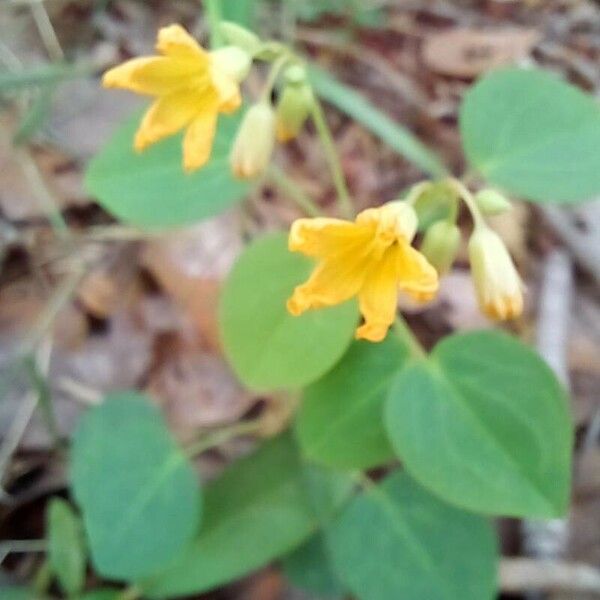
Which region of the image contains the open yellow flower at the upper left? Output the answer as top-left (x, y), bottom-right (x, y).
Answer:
top-left (103, 25), bottom-right (250, 171)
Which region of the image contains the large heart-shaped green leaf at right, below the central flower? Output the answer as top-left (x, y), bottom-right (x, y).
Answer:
top-left (386, 331), bottom-right (572, 517)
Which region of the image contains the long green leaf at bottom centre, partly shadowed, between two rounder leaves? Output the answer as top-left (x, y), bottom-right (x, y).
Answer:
top-left (143, 435), bottom-right (350, 598)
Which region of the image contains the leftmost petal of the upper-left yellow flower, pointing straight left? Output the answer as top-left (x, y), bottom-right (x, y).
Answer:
top-left (102, 56), bottom-right (202, 96)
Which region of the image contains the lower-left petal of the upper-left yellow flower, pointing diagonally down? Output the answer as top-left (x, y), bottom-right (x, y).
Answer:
top-left (134, 91), bottom-right (203, 151)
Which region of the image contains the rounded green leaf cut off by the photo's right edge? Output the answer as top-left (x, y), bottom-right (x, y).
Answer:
top-left (460, 69), bottom-right (600, 202)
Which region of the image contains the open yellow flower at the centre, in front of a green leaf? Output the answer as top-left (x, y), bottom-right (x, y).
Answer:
top-left (287, 202), bottom-right (438, 342)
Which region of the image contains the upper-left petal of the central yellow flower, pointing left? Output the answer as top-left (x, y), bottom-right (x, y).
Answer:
top-left (289, 217), bottom-right (373, 258)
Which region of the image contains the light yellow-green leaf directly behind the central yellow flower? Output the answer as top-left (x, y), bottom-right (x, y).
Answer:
top-left (219, 233), bottom-right (358, 390)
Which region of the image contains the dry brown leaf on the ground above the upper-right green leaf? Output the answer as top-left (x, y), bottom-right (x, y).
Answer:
top-left (422, 28), bottom-right (540, 78)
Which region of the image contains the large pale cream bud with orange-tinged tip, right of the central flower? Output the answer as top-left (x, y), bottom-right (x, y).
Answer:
top-left (469, 226), bottom-right (523, 321)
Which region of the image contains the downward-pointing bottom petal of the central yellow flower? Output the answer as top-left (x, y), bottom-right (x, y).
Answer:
top-left (356, 245), bottom-right (401, 342)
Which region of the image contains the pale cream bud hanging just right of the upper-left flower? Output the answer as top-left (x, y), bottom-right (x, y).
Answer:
top-left (229, 102), bottom-right (275, 179)
